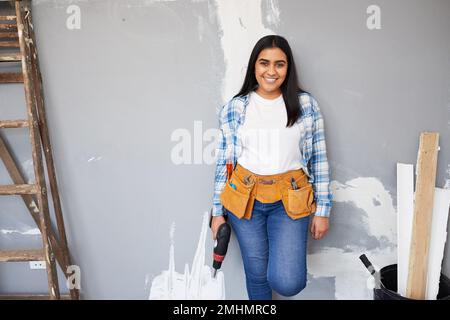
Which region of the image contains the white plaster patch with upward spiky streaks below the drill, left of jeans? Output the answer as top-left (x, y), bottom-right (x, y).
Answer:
top-left (149, 212), bottom-right (225, 300)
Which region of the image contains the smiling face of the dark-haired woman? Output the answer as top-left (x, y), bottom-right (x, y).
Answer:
top-left (255, 48), bottom-right (288, 99)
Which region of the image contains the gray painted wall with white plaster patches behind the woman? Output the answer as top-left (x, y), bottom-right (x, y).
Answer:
top-left (0, 0), bottom-right (450, 299)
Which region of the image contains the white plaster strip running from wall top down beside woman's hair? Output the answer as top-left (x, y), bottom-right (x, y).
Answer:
top-left (216, 0), bottom-right (279, 107)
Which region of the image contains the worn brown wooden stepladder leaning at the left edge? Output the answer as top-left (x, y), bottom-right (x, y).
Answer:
top-left (0, 0), bottom-right (79, 299)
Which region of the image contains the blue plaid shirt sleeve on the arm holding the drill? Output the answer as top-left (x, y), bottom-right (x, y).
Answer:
top-left (212, 105), bottom-right (230, 216)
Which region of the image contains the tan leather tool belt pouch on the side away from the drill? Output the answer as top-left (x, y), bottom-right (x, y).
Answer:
top-left (282, 183), bottom-right (316, 220)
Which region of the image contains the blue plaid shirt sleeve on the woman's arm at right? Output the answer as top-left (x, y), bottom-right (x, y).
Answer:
top-left (309, 99), bottom-right (332, 217)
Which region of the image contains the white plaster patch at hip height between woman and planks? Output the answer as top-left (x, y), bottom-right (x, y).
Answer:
top-left (331, 177), bottom-right (397, 243)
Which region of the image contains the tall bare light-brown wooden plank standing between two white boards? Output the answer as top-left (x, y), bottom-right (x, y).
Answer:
top-left (406, 132), bottom-right (439, 300)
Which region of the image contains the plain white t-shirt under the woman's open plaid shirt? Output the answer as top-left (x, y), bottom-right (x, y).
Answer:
top-left (237, 91), bottom-right (302, 175)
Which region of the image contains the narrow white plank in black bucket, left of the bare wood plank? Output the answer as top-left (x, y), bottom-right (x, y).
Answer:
top-left (397, 163), bottom-right (414, 297)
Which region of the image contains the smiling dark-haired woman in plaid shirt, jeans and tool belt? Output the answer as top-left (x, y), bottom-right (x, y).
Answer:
top-left (211, 35), bottom-right (332, 300)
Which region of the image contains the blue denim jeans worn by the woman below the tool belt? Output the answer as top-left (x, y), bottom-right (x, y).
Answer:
top-left (226, 200), bottom-right (309, 300)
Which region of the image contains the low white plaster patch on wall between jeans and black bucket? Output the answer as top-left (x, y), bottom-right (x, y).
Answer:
top-left (308, 248), bottom-right (397, 300)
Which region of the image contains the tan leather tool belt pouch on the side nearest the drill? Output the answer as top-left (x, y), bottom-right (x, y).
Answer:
top-left (220, 172), bottom-right (254, 219)
